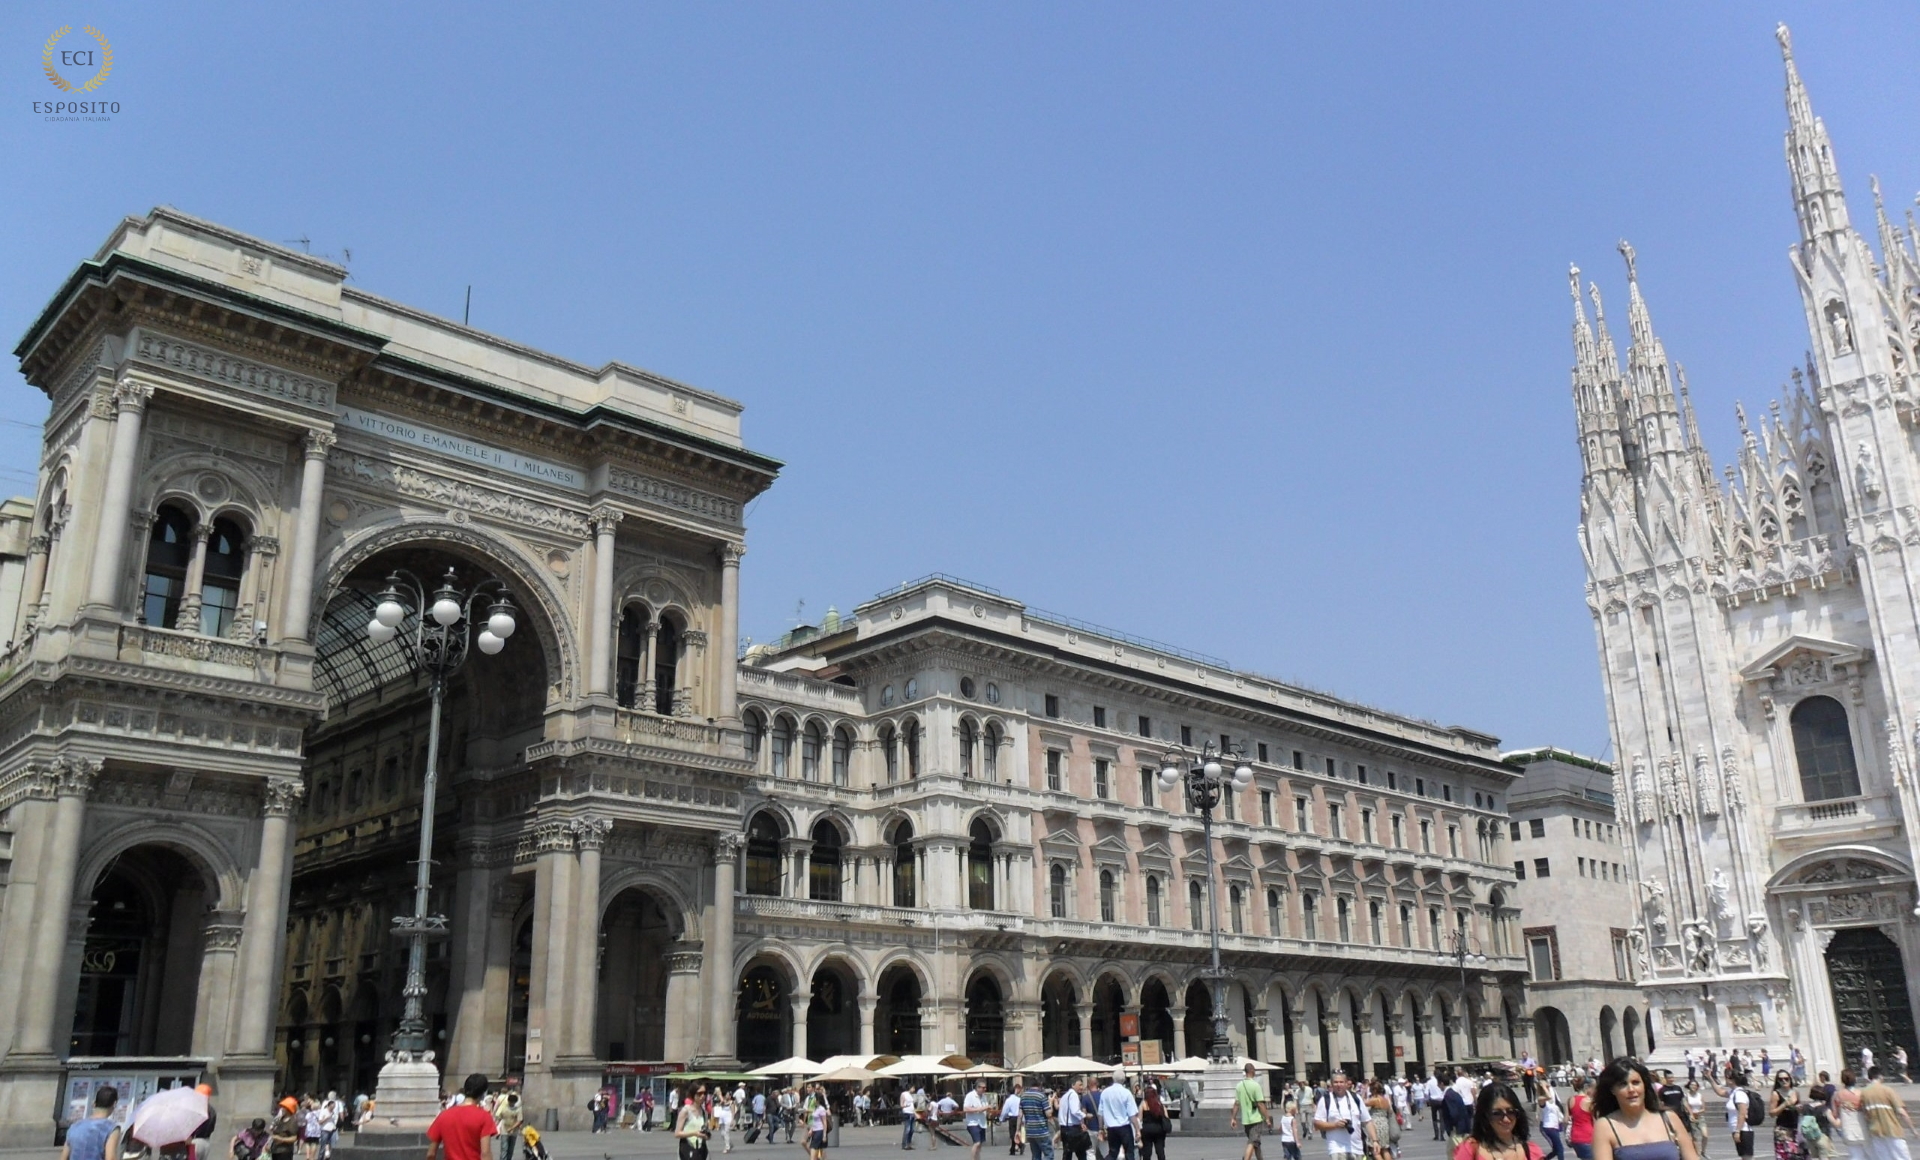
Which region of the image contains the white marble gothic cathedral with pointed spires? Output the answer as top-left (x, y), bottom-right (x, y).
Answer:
top-left (1572, 27), bottom-right (1920, 1072)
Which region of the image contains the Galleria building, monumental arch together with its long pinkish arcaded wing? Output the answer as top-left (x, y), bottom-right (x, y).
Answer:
top-left (0, 209), bottom-right (1528, 1145)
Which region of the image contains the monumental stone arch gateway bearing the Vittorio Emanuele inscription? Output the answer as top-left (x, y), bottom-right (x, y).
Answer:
top-left (0, 209), bottom-right (780, 1145)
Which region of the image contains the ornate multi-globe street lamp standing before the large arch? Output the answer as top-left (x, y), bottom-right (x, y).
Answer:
top-left (367, 567), bottom-right (518, 1067)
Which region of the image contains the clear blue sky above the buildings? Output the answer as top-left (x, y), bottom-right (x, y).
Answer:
top-left (0, 2), bottom-right (1920, 753)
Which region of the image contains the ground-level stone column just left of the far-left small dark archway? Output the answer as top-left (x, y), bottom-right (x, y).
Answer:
top-left (10, 757), bottom-right (100, 1060)
